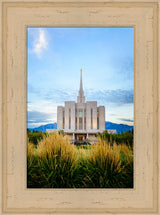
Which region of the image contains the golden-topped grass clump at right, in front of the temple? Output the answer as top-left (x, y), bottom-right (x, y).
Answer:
top-left (82, 140), bottom-right (123, 188)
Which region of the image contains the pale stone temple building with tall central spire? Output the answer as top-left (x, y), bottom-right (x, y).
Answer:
top-left (57, 70), bottom-right (105, 142)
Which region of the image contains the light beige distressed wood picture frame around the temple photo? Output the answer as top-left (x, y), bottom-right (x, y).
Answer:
top-left (0, 0), bottom-right (160, 215)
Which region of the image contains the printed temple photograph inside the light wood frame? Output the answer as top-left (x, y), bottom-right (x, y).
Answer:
top-left (27, 27), bottom-right (134, 188)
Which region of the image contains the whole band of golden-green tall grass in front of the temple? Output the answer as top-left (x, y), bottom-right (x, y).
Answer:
top-left (27, 133), bottom-right (133, 188)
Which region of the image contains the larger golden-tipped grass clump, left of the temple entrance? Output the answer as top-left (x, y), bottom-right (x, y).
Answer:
top-left (28, 133), bottom-right (85, 188)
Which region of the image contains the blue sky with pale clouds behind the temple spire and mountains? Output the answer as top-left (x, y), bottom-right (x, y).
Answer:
top-left (27, 27), bottom-right (134, 128)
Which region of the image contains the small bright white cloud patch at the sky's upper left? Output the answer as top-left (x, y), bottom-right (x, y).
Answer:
top-left (32, 28), bottom-right (48, 57)
